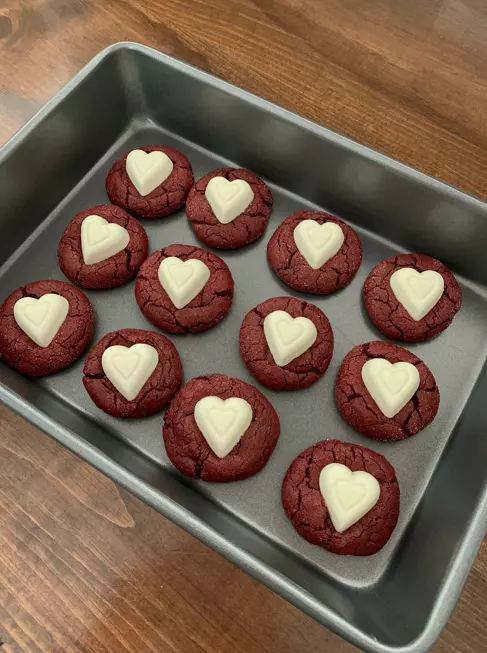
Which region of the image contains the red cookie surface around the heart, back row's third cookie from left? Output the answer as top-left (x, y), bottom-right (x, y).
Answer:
top-left (267, 211), bottom-right (362, 295)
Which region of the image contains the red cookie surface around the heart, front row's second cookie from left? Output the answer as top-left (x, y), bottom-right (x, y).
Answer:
top-left (83, 329), bottom-right (182, 417)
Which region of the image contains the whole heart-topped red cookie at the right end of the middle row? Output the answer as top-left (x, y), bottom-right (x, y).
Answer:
top-left (335, 341), bottom-right (440, 440)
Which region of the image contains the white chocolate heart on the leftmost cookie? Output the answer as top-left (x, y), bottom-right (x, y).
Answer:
top-left (14, 293), bottom-right (69, 347)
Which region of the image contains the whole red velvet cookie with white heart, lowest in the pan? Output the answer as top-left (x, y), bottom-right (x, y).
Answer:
top-left (282, 440), bottom-right (399, 556)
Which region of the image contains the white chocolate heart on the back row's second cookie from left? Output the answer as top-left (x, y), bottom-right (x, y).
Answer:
top-left (205, 177), bottom-right (254, 224)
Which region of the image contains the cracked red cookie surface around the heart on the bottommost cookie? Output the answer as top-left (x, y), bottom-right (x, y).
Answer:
top-left (282, 440), bottom-right (399, 556)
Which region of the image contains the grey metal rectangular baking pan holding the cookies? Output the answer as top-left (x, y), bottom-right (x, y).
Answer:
top-left (0, 43), bottom-right (487, 653)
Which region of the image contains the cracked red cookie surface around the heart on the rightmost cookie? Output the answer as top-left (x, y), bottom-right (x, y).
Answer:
top-left (362, 254), bottom-right (462, 342)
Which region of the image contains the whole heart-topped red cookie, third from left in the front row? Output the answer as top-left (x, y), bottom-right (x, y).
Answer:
top-left (163, 374), bottom-right (279, 482)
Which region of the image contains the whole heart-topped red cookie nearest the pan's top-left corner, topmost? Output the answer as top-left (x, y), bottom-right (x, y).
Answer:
top-left (106, 145), bottom-right (194, 218)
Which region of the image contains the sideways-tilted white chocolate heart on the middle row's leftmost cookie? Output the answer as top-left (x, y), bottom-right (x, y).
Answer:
top-left (81, 215), bottom-right (130, 265)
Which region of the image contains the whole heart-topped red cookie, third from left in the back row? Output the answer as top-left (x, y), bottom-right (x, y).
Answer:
top-left (267, 211), bottom-right (362, 295)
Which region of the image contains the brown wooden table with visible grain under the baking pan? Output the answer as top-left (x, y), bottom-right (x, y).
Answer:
top-left (0, 0), bottom-right (487, 653)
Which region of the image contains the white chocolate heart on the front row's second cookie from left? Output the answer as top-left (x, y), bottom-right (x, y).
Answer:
top-left (101, 343), bottom-right (159, 401)
